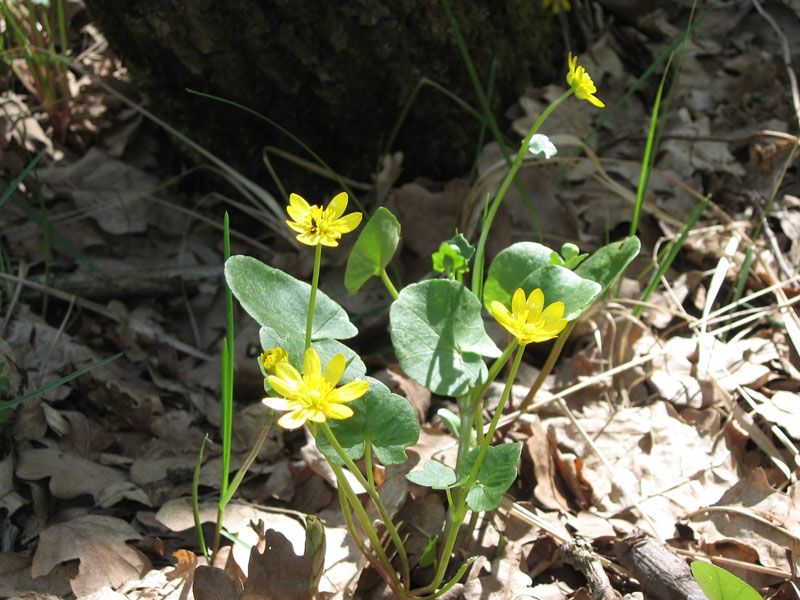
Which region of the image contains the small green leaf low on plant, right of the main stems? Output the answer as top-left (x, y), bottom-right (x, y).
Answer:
top-left (461, 444), bottom-right (522, 511)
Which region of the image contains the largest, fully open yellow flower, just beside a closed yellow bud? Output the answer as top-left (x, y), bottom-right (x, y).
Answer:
top-left (262, 348), bottom-right (369, 429)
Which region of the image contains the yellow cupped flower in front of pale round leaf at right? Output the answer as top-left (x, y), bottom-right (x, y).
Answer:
top-left (489, 288), bottom-right (568, 345)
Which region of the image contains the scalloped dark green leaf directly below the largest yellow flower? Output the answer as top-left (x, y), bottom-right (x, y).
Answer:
top-left (317, 377), bottom-right (419, 465)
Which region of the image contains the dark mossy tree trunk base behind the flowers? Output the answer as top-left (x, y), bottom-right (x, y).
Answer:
top-left (79, 0), bottom-right (563, 185)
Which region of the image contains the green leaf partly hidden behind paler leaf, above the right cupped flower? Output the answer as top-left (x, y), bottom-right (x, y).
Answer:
top-left (483, 242), bottom-right (561, 310)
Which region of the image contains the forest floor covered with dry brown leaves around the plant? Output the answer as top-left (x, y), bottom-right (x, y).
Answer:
top-left (0, 0), bottom-right (800, 600)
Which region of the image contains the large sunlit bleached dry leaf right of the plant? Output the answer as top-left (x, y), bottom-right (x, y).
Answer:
top-left (545, 402), bottom-right (736, 539)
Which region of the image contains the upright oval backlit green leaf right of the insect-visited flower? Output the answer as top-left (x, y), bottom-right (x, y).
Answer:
top-left (344, 206), bottom-right (400, 294)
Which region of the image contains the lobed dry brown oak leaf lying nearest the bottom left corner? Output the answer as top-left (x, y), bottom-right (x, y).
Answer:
top-left (31, 515), bottom-right (150, 598)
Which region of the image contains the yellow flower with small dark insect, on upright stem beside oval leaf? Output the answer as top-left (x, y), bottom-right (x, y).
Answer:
top-left (286, 192), bottom-right (361, 247)
